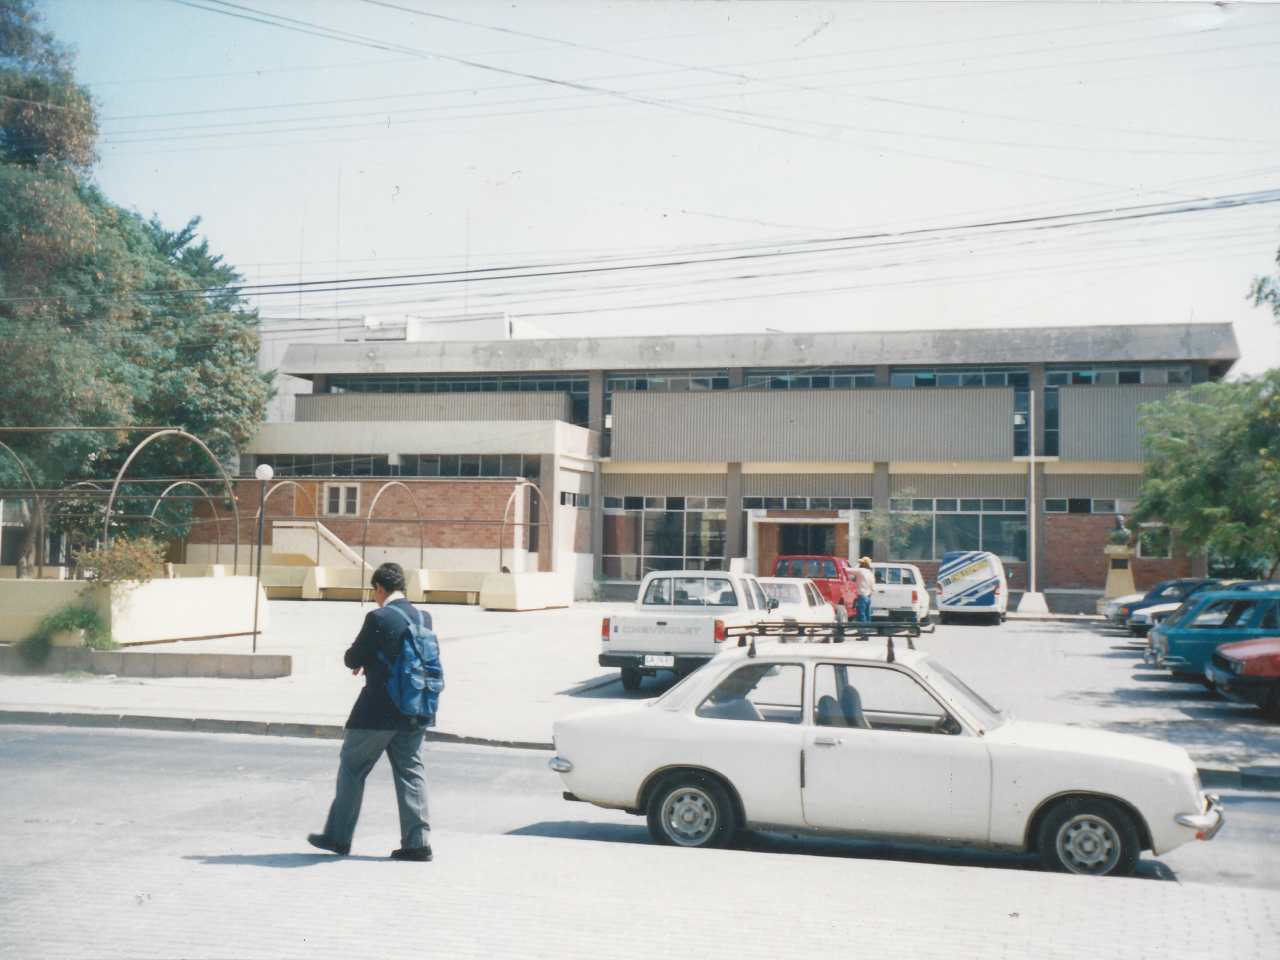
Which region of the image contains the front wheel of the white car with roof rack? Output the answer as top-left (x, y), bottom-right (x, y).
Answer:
top-left (1037, 797), bottom-right (1140, 877)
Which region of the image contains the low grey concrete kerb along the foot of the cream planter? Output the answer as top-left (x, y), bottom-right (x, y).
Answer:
top-left (0, 646), bottom-right (293, 680)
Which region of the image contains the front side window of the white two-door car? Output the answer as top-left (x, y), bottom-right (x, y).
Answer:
top-left (813, 663), bottom-right (960, 733)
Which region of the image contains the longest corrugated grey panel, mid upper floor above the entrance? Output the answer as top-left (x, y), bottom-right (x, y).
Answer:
top-left (613, 387), bottom-right (1014, 463)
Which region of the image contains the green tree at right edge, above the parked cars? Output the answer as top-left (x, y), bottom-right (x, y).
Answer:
top-left (1132, 370), bottom-right (1280, 571)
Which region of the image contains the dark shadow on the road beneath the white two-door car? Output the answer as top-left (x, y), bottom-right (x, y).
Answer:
top-left (507, 820), bottom-right (1178, 881)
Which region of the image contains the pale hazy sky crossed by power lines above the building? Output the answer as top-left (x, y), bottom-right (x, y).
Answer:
top-left (44, 0), bottom-right (1280, 371)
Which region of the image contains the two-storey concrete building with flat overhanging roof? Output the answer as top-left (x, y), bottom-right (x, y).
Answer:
top-left (215, 323), bottom-right (1239, 607)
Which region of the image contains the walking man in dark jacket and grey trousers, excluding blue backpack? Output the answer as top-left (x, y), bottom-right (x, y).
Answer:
top-left (307, 563), bottom-right (435, 860)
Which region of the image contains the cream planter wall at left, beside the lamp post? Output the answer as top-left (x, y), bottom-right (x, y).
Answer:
top-left (0, 577), bottom-right (270, 645)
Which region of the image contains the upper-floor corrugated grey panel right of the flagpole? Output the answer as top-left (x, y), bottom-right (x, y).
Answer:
top-left (1059, 384), bottom-right (1187, 463)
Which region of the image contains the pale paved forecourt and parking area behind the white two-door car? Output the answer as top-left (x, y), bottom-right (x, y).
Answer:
top-left (0, 600), bottom-right (1280, 787)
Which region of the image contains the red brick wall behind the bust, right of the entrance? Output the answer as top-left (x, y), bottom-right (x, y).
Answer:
top-left (1039, 513), bottom-right (1192, 590)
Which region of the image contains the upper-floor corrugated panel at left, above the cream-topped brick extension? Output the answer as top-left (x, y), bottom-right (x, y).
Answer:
top-left (294, 393), bottom-right (570, 422)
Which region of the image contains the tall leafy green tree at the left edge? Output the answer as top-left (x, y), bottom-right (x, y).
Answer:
top-left (0, 0), bottom-right (271, 564)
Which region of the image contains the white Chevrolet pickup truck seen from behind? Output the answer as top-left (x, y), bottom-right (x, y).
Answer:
top-left (600, 570), bottom-right (778, 690)
